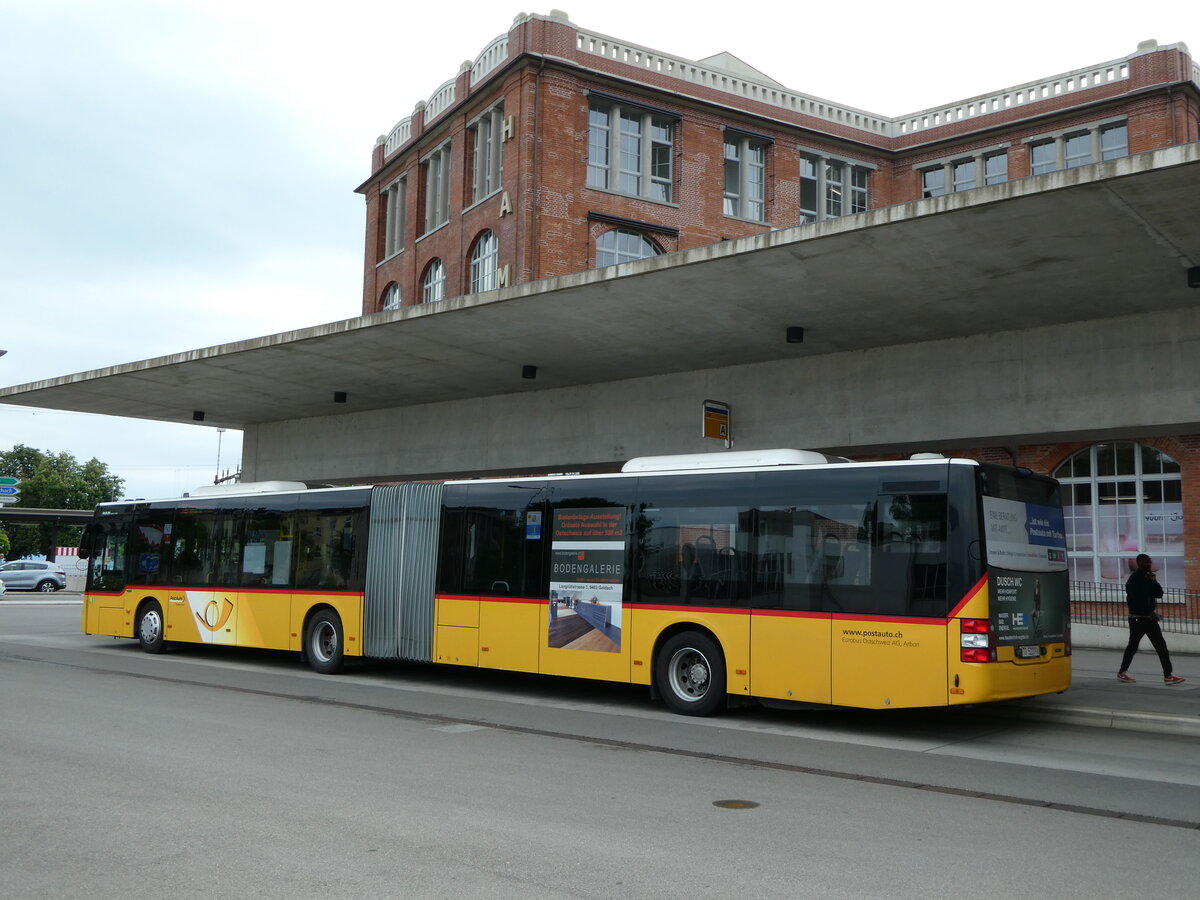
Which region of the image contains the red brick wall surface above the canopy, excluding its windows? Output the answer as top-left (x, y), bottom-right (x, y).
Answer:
top-left (359, 16), bottom-right (1200, 313)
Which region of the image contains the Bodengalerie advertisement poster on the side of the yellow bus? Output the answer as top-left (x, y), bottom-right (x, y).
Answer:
top-left (548, 508), bottom-right (625, 653)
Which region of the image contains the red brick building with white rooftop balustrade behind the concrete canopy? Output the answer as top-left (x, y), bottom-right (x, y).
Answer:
top-left (359, 13), bottom-right (1200, 589)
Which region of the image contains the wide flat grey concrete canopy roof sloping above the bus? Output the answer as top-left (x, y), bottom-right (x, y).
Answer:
top-left (0, 143), bottom-right (1200, 428)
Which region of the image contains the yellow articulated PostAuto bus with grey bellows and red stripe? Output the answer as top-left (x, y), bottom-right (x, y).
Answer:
top-left (82, 450), bottom-right (1070, 715)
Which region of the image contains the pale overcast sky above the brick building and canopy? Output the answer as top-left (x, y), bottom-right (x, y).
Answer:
top-left (0, 0), bottom-right (1200, 497)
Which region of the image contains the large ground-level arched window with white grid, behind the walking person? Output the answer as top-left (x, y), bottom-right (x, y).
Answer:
top-left (1054, 440), bottom-right (1187, 588)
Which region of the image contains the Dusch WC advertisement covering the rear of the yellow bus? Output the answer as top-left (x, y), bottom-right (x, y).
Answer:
top-left (983, 497), bottom-right (1070, 647)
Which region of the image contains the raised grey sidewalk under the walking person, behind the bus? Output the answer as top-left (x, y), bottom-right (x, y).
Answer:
top-left (1000, 648), bottom-right (1200, 737)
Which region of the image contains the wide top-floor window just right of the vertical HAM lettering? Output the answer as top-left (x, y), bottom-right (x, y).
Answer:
top-left (588, 100), bottom-right (674, 203)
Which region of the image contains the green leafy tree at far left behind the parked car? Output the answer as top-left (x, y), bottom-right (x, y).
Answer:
top-left (0, 444), bottom-right (125, 559)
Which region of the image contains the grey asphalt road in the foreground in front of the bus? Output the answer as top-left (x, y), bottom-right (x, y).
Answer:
top-left (0, 602), bottom-right (1200, 898)
